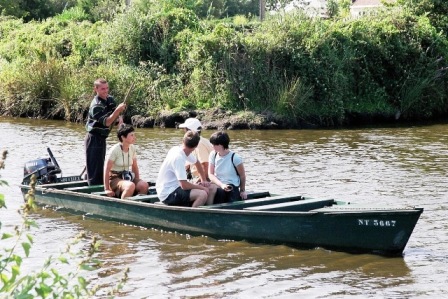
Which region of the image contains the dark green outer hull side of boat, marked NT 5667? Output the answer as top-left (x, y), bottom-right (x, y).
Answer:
top-left (21, 185), bottom-right (423, 256)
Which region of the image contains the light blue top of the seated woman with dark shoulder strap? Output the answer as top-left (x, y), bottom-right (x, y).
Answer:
top-left (208, 151), bottom-right (243, 187)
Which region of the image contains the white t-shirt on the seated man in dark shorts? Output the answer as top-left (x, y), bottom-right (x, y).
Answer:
top-left (156, 146), bottom-right (196, 201)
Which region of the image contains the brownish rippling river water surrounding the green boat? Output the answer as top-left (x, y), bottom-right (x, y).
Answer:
top-left (0, 118), bottom-right (448, 298)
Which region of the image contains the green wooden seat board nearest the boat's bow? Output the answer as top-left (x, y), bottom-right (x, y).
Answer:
top-left (245, 199), bottom-right (335, 212)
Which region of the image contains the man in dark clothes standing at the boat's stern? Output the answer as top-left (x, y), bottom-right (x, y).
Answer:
top-left (84, 78), bottom-right (126, 186)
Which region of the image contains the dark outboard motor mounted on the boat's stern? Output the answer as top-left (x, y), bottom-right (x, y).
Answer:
top-left (22, 148), bottom-right (61, 184)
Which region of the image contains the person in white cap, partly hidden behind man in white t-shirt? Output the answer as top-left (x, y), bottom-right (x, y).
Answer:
top-left (179, 117), bottom-right (213, 182)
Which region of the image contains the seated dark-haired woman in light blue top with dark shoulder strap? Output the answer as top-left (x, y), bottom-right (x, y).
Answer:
top-left (208, 132), bottom-right (247, 204)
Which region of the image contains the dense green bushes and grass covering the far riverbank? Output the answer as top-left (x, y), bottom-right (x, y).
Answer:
top-left (0, 0), bottom-right (448, 127)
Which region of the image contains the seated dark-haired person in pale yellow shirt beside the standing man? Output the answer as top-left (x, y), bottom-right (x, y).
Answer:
top-left (104, 124), bottom-right (149, 198)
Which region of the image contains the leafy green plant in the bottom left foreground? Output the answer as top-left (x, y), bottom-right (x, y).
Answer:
top-left (0, 151), bottom-right (129, 299)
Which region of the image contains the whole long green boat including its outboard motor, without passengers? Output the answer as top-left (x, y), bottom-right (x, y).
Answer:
top-left (20, 150), bottom-right (423, 256)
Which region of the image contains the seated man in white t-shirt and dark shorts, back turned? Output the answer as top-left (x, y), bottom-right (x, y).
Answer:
top-left (156, 131), bottom-right (217, 207)
